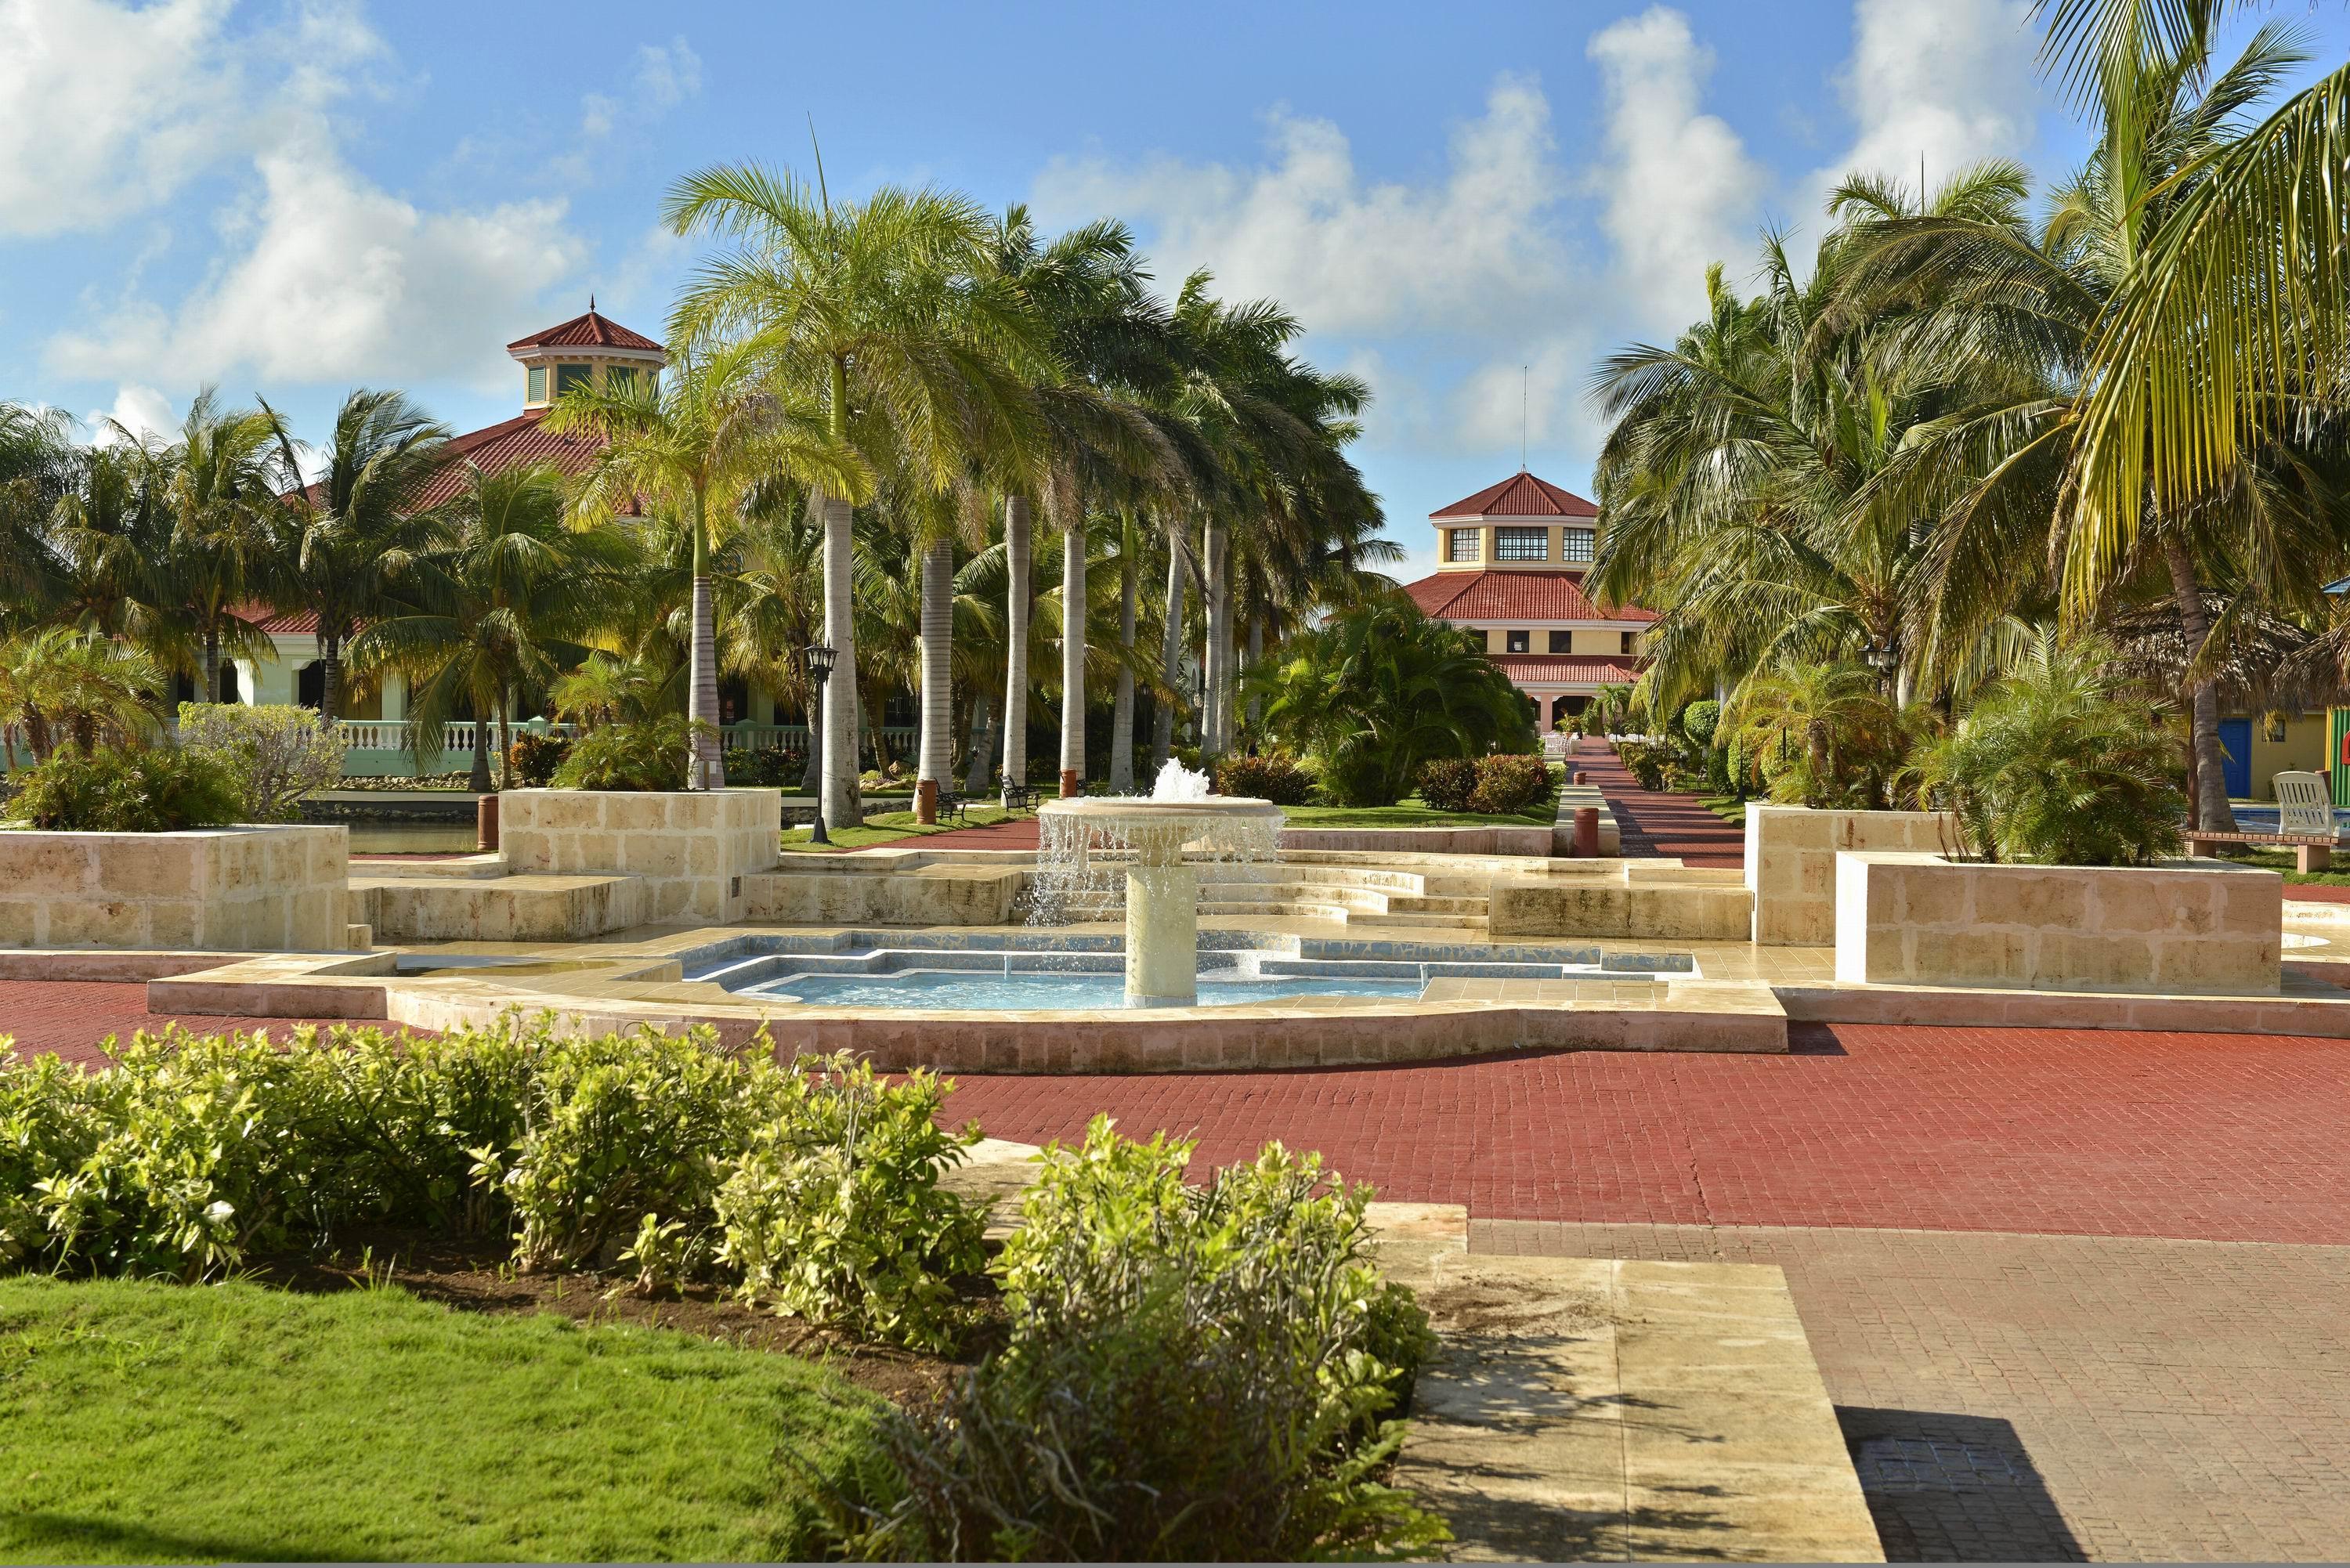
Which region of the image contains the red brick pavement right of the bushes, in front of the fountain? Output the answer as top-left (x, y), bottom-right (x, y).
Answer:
top-left (947, 1025), bottom-right (2350, 1244)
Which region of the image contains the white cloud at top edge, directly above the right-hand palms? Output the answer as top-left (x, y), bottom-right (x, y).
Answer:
top-left (1805, 0), bottom-right (2037, 219)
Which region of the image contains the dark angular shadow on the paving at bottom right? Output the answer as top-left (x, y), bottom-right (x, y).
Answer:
top-left (1835, 1406), bottom-right (2087, 1563)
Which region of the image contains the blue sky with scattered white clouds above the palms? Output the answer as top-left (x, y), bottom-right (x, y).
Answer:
top-left (0, 0), bottom-right (2350, 578)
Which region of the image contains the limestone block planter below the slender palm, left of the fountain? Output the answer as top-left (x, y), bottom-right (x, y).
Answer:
top-left (498, 790), bottom-right (783, 924)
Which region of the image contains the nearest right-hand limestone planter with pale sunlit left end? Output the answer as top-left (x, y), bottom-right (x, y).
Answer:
top-left (1835, 851), bottom-right (2284, 992)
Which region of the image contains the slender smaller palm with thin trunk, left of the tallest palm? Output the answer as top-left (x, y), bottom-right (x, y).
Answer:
top-left (545, 341), bottom-right (865, 790)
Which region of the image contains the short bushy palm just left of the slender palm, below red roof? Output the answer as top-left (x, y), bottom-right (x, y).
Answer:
top-left (352, 463), bottom-right (637, 793)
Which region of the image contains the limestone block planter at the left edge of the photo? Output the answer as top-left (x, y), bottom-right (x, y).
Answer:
top-left (0, 823), bottom-right (350, 952)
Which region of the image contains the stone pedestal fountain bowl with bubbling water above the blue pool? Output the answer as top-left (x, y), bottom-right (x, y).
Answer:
top-left (1036, 759), bottom-right (1281, 1006)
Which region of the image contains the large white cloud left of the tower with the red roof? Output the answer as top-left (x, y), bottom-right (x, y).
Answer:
top-left (49, 143), bottom-right (585, 388)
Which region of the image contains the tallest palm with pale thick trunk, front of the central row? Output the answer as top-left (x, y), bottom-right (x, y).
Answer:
top-left (663, 164), bottom-right (1036, 821)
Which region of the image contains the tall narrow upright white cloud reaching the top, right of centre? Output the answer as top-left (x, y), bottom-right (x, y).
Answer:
top-left (1586, 5), bottom-right (1772, 334)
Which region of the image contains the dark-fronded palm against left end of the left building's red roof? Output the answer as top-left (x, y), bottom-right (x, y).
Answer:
top-left (261, 399), bottom-right (449, 731)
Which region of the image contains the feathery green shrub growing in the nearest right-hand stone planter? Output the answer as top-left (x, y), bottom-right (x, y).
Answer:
top-left (1920, 632), bottom-right (2186, 865)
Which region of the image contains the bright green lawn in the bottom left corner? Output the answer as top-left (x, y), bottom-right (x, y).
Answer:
top-left (0, 1277), bottom-right (879, 1561)
